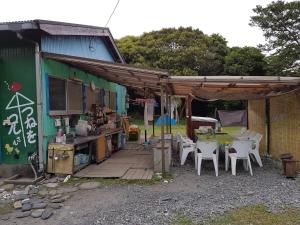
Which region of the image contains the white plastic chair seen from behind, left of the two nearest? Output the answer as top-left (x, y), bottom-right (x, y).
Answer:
top-left (196, 141), bottom-right (219, 177)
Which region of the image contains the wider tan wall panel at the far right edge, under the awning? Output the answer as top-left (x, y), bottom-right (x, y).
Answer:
top-left (270, 92), bottom-right (300, 169)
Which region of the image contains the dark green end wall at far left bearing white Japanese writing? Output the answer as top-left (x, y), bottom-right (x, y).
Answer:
top-left (0, 43), bottom-right (38, 164)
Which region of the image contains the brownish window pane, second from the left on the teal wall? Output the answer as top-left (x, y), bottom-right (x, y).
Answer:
top-left (67, 80), bottom-right (82, 114)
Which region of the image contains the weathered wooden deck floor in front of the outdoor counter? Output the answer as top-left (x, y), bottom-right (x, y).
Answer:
top-left (74, 143), bottom-right (153, 180)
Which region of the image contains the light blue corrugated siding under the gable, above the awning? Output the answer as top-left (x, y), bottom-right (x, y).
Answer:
top-left (41, 35), bottom-right (114, 62)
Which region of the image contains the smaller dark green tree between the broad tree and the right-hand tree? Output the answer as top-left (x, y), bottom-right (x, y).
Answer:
top-left (224, 47), bottom-right (266, 76)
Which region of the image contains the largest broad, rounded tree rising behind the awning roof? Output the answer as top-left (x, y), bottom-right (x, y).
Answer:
top-left (117, 27), bottom-right (228, 75)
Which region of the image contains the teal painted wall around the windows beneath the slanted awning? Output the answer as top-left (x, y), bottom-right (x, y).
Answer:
top-left (41, 59), bottom-right (126, 160)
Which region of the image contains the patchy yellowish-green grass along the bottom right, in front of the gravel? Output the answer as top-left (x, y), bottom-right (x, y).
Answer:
top-left (170, 205), bottom-right (300, 225)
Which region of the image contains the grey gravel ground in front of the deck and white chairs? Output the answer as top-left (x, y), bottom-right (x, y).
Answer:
top-left (0, 157), bottom-right (300, 225)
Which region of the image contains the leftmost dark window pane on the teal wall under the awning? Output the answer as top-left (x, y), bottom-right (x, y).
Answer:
top-left (49, 76), bottom-right (67, 115)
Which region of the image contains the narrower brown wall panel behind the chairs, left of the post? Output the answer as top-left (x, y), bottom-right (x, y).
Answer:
top-left (248, 99), bottom-right (267, 155)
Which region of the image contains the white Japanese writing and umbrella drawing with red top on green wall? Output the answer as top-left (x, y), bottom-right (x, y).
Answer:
top-left (4, 82), bottom-right (37, 154)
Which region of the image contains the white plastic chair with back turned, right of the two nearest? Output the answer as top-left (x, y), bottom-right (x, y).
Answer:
top-left (229, 140), bottom-right (253, 176)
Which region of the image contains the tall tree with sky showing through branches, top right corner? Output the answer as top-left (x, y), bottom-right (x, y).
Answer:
top-left (250, 1), bottom-right (300, 75)
